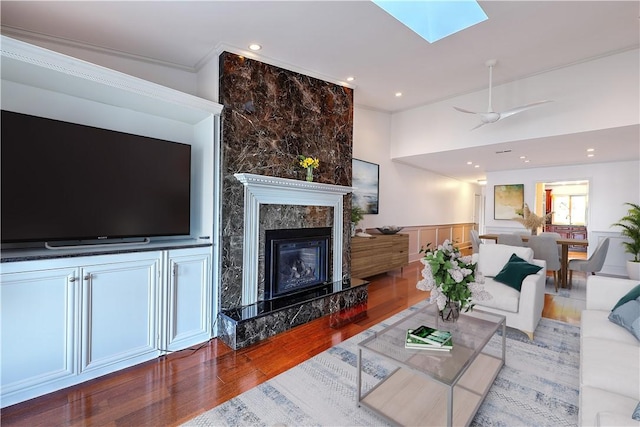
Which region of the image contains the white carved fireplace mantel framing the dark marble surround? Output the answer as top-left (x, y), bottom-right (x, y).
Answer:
top-left (235, 173), bottom-right (353, 306)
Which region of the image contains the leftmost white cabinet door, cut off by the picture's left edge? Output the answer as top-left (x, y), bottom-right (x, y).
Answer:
top-left (0, 268), bottom-right (78, 406)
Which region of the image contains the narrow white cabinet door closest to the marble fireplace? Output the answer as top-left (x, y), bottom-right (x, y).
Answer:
top-left (165, 248), bottom-right (212, 351)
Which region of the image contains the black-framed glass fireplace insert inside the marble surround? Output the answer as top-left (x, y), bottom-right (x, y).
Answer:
top-left (265, 228), bottom-right (331, 300)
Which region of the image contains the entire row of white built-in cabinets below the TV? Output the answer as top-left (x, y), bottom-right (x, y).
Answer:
top-left (0, 246), bottom-right (213, 407)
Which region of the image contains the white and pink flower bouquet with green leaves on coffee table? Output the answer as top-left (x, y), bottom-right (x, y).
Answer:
top-left (416, 240), bottom-right (490, 312)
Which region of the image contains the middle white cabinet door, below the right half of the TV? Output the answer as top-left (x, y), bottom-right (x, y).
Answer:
top-left (81, 254), bottom-right (161, 373)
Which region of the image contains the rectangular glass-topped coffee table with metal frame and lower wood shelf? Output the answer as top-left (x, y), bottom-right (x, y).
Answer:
top-left (356, 304), bottom-right (506, 426)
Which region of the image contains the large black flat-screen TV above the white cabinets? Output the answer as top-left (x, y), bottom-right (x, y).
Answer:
top-left (0, 110), bottom-right (191, 243)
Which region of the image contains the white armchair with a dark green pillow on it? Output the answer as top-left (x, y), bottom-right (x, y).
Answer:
top-left (473, 244), bottom-right (547, 339)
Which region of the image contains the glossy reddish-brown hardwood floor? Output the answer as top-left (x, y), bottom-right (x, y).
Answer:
top-left (0, 262), bottom-right (580, 427)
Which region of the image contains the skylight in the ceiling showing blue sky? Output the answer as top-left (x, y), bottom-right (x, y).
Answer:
top-left (372, 0), bottom-right (488, 43)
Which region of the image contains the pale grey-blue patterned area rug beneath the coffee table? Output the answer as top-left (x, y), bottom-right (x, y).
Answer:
top-left (184, 303), bottom-right (580, 427)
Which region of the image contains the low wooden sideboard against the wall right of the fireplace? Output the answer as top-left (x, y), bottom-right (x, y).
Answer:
top-left (351, 234), bottom-right (409, 278)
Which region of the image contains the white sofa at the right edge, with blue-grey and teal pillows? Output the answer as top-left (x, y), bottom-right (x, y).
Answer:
top-left (580, 276), bottom-right (640, 426)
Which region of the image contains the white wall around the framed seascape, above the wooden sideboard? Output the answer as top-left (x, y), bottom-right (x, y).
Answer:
top-left (353, 107), bottom-right (481, 228)
